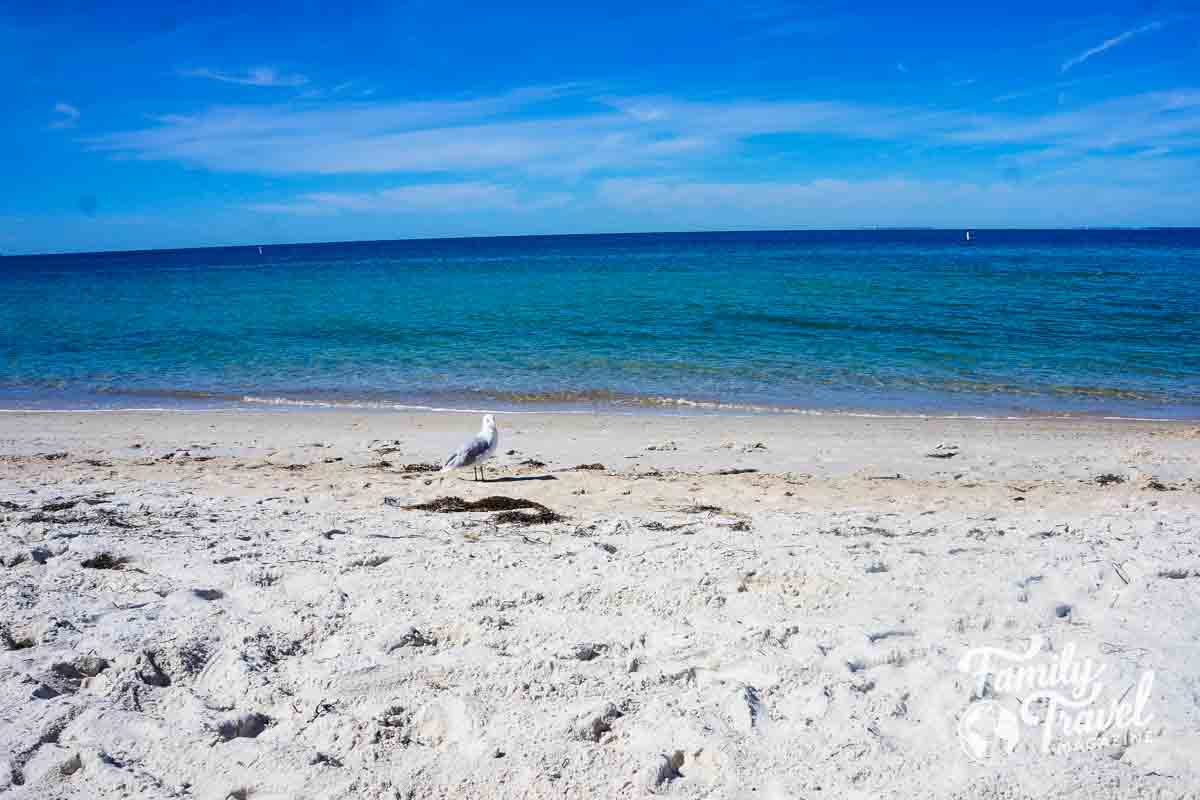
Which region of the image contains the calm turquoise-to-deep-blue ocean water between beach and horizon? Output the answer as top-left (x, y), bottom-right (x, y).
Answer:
top-left (0, 229), bottom-right (1200, 419)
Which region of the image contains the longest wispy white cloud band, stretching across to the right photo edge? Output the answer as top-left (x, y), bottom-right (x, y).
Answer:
top-left (88, 86), bottom-right (1200, 189)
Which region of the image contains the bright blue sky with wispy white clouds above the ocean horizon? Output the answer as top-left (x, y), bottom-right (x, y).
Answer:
top-left (0, 0), bottom-right (1200, 253)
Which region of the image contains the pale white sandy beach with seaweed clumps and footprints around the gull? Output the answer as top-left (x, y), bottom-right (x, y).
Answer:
top-left (0, 409), bottom-right (1200, 800)
